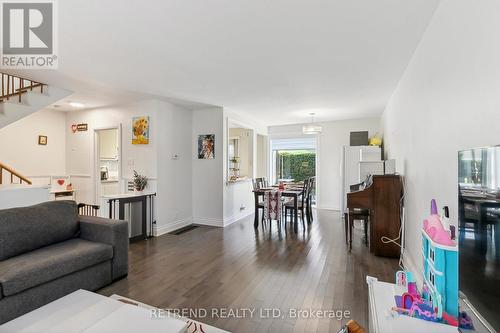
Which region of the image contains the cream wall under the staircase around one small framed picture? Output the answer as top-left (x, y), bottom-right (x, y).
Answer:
top-left (0, 110), bottom-right (66, 182)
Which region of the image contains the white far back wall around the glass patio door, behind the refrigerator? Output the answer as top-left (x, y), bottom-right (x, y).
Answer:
top-left (269, 118), bottom-right (380, 210)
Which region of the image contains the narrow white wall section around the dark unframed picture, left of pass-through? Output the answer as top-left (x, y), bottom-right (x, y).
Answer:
top-left (191, 108), bottom-right (226, 226)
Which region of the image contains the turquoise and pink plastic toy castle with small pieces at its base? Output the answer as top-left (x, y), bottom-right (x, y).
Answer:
top-left (393, 200), bottom-right (458, 326)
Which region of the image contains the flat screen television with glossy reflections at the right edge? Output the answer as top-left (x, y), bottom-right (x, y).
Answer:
top-left (458, 146), bottom-right (500, 332)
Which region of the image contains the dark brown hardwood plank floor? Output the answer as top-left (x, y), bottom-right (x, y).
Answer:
top-left (99, 210), bottom-right (397, 332)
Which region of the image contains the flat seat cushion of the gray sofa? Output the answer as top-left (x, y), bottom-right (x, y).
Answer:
top-left (0, 238), bottom-right (113, 297)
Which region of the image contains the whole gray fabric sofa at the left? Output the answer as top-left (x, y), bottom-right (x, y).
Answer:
top-left (0, 201), bottom-right (129, 324)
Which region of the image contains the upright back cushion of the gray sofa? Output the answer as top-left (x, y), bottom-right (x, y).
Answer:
top-left (0, 201), bottom-right (79, 261)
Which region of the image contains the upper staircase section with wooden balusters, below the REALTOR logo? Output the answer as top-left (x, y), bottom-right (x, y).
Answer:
top-left (0, 72), bottom-right (71, 128)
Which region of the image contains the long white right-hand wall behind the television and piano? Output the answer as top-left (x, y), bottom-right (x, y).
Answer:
top-left (383, 0), bottom-right (500, 278)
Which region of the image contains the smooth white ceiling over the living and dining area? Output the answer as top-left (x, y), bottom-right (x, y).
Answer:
top-left (8, 0), bottom-right (439, 125)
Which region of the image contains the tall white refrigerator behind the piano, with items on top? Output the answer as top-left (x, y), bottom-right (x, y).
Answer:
top-left (340, 146), bottom-right (384, 214)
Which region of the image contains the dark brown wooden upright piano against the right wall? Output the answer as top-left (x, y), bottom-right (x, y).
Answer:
top-left (347, 175), bottom-right (403, 258)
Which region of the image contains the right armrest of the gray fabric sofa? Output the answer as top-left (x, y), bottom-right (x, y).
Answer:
top-left (78, 215), bottom-right (129, 280)
